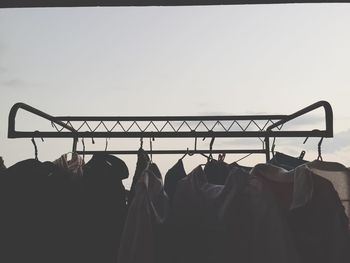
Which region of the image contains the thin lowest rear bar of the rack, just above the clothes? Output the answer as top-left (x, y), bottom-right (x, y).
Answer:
top-left (77, 149), bottom-right (265, 155)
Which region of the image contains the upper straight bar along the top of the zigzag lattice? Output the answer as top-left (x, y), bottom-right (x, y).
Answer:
top-left (55, 115), bottom-right (288, 121)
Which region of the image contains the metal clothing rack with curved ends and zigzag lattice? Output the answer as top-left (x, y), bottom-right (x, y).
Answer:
top-left (8, 101), bottom-right (333, 161)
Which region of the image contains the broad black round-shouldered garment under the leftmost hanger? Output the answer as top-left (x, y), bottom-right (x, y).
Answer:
top-left (0, 159), bottom-right (78, 263)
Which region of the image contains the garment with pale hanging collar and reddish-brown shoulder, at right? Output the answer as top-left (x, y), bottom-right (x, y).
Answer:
top-left (252, 164), bottom-right (350, 263)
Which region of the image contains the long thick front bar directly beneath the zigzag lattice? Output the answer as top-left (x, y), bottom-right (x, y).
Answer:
top-left (8, 130), bottom-right (332, 138)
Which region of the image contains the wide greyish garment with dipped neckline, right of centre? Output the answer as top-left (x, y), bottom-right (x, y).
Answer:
top-left (169, 166), bottom-right (298, 263)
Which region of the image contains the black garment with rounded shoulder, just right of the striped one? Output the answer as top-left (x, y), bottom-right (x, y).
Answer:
top-left (82, 154), bottom-right (128, 263)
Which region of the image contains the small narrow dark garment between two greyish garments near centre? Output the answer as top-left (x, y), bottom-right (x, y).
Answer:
top-left (164, 159), bottom-right (186, 203)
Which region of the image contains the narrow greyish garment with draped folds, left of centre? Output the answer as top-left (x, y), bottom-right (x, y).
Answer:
top-left (117, 163), bottom-right (169, 263)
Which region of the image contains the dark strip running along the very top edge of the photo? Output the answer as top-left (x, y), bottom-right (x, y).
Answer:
top-left (0, 0), bottom-right (348, 8)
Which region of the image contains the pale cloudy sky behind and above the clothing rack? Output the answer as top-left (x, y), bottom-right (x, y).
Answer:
top-left (0, 4), bottom-right (350, 189)
